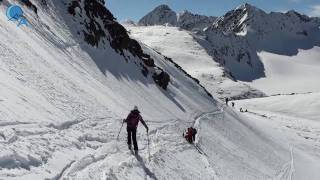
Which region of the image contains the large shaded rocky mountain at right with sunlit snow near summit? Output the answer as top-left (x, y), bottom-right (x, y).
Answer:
top-left (205, 4), bottom-right (320, 80)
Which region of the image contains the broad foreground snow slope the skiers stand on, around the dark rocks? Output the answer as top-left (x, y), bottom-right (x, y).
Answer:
top-left (0, 0), bottom-right (320, 180)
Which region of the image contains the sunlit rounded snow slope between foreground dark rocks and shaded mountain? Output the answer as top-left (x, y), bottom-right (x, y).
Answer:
top-left (123, 23), bottom-right (264, 99)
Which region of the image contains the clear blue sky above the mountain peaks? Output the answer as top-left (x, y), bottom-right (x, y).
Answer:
top-left (106, 0), bottom-right (320, 21)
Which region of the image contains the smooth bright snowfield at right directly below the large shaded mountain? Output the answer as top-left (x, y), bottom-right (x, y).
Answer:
top-left (248, 46), bottom-right (320, 95)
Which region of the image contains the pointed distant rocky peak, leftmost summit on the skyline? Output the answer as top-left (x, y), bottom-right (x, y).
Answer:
top-left (138, 5), bottom-right (177, 26)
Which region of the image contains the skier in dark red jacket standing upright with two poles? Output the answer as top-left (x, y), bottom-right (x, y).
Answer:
top-left (123, 106), bottom-right (149, 153)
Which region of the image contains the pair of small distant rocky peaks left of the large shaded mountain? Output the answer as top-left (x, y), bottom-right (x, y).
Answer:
top-left (138, 5), bottom-right (216, 31)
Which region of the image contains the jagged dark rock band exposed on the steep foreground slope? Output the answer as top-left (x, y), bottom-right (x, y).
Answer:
top-left (68, 0), bottom-right (174, 89)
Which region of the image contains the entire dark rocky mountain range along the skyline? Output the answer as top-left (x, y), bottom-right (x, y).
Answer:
top-left (139, 4), bottom-right (320, 82)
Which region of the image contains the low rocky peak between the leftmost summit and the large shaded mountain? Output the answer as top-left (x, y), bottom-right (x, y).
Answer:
top-left (178, 11), bottom-right (216, 31)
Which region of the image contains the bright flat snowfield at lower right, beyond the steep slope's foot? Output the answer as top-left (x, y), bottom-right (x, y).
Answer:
top-left (236, 93), bottom-right (320, 179)
